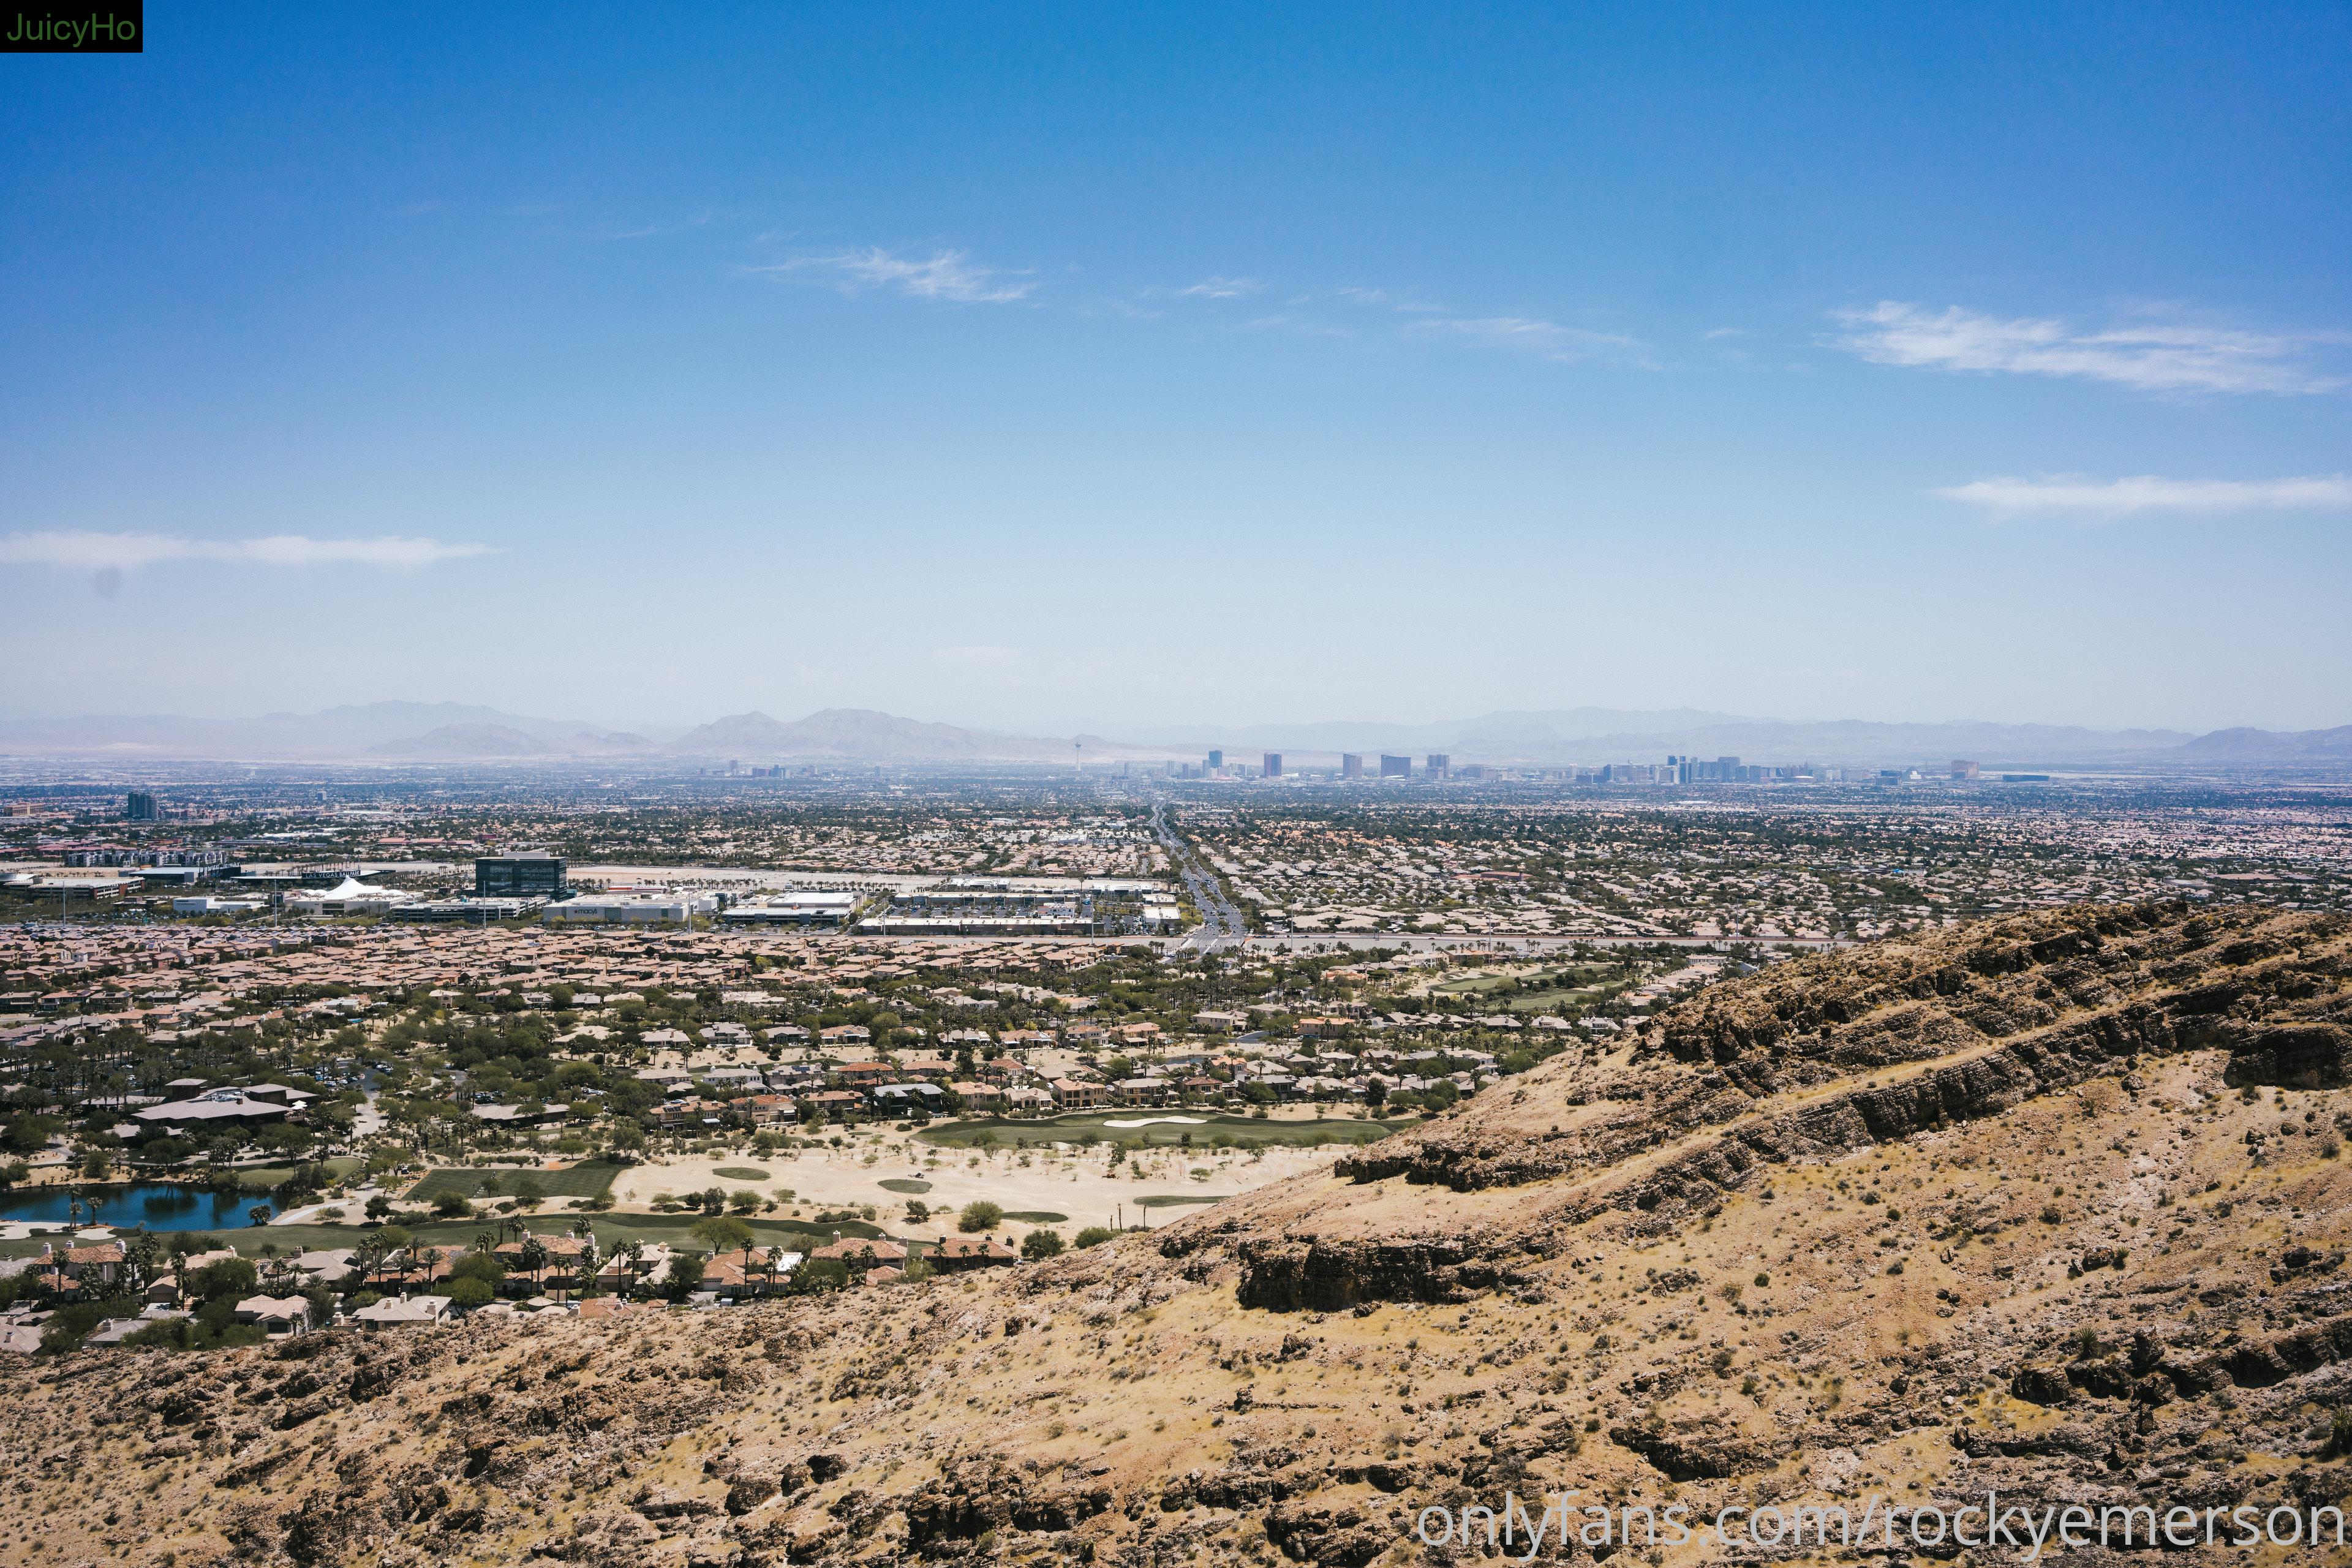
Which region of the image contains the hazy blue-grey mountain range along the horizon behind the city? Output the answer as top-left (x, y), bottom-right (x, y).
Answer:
top-left (0, 703), bottom-right (2352, 771)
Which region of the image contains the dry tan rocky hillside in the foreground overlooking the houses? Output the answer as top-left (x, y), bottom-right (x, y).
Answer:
top-left (0, 907), bottom-right (2352, 1568)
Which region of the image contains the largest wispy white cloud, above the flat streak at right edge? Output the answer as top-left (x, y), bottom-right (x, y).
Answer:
top-left (1837, 301), bottom-right (2345, 393)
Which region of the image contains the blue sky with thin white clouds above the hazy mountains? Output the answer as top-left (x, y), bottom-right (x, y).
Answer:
top-left (0, 2), bottom-right (2352, 733)
